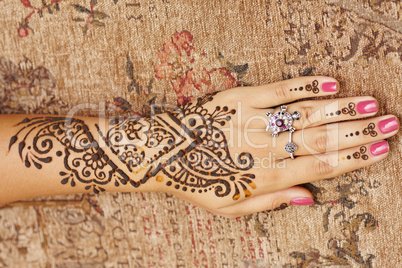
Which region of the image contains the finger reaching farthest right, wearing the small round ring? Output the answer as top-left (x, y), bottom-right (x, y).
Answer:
top-left (245, 115), bottom-right (399, 159)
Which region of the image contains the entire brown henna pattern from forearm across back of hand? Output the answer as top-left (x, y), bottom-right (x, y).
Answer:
top-left (9, 94), bottom-right (256, 200)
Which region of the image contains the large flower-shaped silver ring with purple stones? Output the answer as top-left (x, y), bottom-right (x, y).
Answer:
top-left (266, 105), bottom-right (300, 137)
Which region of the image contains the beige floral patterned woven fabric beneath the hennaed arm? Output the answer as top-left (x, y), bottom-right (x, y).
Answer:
top-left (0, 0), bottom-right (402, 267)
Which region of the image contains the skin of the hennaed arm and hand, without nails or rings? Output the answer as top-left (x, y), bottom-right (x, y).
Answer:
top-left (0, 76), bottom-right (399, 217)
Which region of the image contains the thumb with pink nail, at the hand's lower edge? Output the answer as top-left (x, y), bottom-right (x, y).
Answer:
top-left (216, 186), bottom-right (314, 218)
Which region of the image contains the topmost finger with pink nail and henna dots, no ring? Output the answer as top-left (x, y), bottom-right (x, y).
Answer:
top-left (236, 76), bottom-right (339, 108)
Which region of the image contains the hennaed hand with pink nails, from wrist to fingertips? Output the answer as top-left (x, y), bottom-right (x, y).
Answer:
top-left (157, 76), bottom-right (399, 217)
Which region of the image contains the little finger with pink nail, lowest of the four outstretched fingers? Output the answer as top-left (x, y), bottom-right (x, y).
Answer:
top-left (278, 140), bottom-right (389, 189)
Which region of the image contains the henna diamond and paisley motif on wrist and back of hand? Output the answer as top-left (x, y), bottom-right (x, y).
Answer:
top-left (99, 91), bottom-right (256, 200)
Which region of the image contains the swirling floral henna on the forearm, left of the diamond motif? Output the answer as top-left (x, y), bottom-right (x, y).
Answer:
top-left (9, 117), bottom-right (131, 193)
